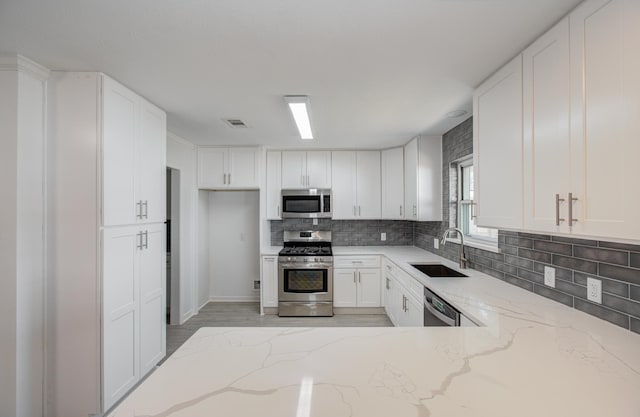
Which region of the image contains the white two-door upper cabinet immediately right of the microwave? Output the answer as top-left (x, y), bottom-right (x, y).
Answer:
top-left (331, 151), bottom-right (381, 219)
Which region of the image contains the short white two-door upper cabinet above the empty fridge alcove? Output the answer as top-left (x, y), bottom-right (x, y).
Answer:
top-left (198, 146), bottom-right (261, 190)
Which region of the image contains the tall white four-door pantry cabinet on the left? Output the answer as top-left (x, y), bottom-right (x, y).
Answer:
top-left (47, 72), bottom-right (166, 417)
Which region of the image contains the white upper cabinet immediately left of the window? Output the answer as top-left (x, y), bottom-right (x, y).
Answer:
top-left (404, 136), bottom-right (442, 221)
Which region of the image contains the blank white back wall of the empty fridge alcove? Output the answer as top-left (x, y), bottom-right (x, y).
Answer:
top-left (209, 191), bottom-right (260, 301)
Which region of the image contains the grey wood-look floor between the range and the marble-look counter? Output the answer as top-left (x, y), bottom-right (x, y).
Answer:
top-left (166, 303), bottom-right (393, 358)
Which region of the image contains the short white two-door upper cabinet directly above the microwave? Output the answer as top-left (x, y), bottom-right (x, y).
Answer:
top-left (282, 151), bottom-right (331, 188)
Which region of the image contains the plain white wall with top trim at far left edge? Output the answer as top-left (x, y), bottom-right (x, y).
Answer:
top-left (0, 55), bottom-right (49, 417)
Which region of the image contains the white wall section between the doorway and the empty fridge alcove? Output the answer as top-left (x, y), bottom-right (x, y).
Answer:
top-left (167, 132), bottom-right (199, 323)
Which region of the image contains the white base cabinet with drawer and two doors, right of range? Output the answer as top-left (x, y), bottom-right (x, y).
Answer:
top-left (333, 256), bottom-right (382, 307)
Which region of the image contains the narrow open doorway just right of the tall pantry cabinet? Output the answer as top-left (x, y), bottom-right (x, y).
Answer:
top-left (165, 167), bottom-right (180, 324)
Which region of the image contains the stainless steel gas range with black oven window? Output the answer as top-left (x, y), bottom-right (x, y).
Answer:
top-left (278, 231), bottom-right (333, 316)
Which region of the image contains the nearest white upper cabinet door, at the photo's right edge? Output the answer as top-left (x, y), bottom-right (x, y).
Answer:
top-left (563, 0), bottom-right (640, 240)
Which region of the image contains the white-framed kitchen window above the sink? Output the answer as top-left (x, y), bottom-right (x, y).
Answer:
top-left (450, 157), bottom-right (498, 251)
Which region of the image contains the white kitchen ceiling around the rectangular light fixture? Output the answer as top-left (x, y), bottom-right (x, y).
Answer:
top-left (0, 0), bottom-right (580, 148)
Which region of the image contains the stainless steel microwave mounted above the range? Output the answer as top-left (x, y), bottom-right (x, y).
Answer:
top-left (282, 188), bottom-right (332, 219)
